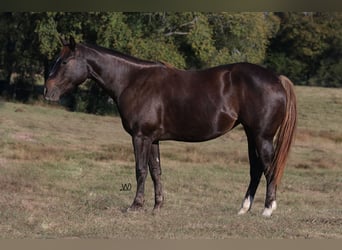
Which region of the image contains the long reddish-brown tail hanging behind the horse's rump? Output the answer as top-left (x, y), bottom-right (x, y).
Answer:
top-left (272, 75), bottom-right (297, 185)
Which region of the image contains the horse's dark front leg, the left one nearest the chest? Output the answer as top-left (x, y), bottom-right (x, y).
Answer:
top-left (128, 136), bottom-right (152, 211)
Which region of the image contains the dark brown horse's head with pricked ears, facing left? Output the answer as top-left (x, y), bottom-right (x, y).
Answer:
top-left (44, 37), bottom-right (88, 101)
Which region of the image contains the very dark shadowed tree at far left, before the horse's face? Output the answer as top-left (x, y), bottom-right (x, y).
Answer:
top-left (0, 12), bottom-right (50, 101)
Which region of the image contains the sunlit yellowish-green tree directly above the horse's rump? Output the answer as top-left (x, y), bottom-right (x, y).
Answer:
top-left (209, 12), bottom-right (280, 64)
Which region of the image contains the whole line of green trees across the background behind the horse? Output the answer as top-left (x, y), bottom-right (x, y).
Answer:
top-left (0, 12), bottom-right (342, 113)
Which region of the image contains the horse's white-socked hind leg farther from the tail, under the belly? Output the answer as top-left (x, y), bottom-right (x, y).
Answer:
top-left (238, 129), bottom-right (263, 215)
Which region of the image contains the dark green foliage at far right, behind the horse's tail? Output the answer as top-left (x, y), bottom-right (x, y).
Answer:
top-left (266, 12), bottom-right (342, 86)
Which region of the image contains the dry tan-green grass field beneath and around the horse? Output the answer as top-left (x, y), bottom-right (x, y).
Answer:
top-left (0, 87), bottom-right (342, 239)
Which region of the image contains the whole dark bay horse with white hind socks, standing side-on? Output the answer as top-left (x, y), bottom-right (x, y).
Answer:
top-left (44, 37), bottom-right (297, 216)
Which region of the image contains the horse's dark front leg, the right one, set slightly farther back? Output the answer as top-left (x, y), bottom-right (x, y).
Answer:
top-left (149, 143), bottom-right (164, 210)
